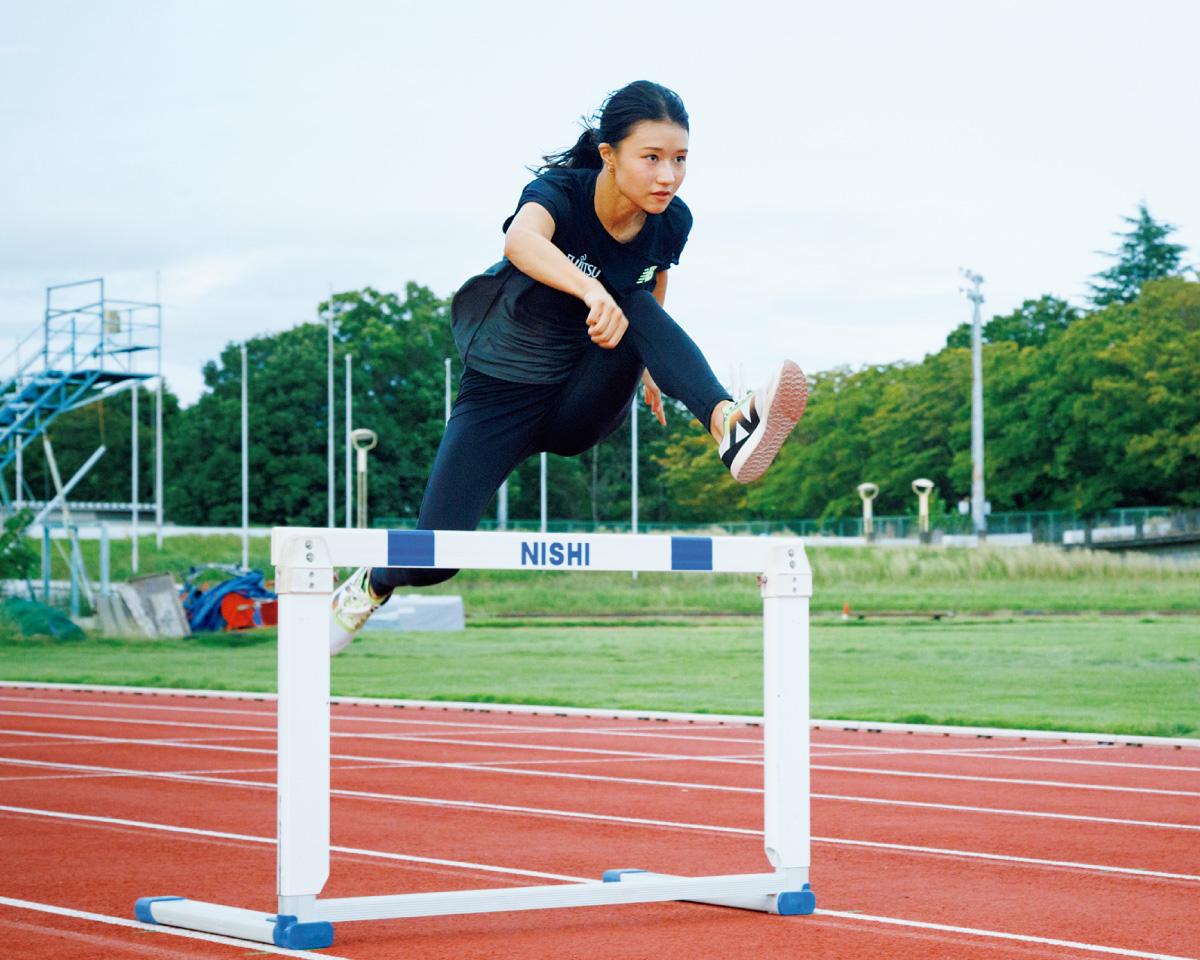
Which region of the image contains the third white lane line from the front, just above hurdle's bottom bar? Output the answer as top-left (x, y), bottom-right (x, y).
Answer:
top-left (0, 757), bottom-right (1200, 834)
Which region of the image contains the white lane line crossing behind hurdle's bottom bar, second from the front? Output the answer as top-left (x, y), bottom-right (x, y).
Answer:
top-left (0, 806), bottom-right (1195, 960)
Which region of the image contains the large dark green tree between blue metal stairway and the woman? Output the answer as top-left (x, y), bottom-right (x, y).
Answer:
top-left (167, 283), bottom-right (454, 526)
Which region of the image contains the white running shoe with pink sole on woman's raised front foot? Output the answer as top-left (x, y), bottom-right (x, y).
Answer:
top-left (716, 360), bottom-right (809, 484)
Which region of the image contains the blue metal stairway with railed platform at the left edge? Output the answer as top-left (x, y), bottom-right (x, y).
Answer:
top-left (0, 278), bottom-right (162, 470)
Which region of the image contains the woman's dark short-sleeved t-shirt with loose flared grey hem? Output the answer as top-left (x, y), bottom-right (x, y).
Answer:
top-left (467, 167), bottom-right (691, 383)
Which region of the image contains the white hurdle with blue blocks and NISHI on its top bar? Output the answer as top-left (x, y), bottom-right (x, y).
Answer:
top-left (134, 527), bottom-right (816, 949)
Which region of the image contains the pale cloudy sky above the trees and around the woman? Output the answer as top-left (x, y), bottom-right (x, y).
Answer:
top-left (0, 0), bottom-right (1200, 403)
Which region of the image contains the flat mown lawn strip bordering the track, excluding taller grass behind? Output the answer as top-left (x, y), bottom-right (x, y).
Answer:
top-left (0, 617), bottom-right (1200, 736)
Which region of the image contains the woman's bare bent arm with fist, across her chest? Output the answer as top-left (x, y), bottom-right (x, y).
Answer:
top-left (504, 202), bottom-right (629, 349)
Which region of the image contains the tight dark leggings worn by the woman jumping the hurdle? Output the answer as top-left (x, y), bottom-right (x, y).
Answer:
top-left (371, 292), bottom-right (730, 595)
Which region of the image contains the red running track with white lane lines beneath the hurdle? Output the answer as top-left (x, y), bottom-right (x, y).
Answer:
top-left (0, 689), bottom-right (1200, 960)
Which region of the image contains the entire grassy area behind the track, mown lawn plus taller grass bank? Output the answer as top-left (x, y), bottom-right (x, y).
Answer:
top-left (7, 536), bottom-right (1200, 736)
